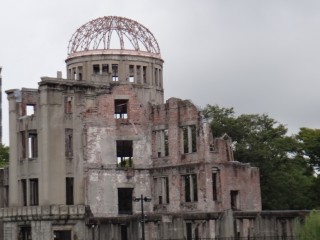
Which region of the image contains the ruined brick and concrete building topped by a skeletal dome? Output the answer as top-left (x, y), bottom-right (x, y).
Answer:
top-left (0, 17), bottom-right (304, 240)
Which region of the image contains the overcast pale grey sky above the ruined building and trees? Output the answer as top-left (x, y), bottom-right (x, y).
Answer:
top-left (0, 0), bottom-right (320, 145)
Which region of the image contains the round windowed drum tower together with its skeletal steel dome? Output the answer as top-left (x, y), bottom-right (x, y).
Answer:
top-left (66, 16), bottom-right (164, 104)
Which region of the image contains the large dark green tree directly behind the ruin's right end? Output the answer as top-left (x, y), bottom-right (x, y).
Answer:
top-left (204, 105), bottom-right (320, 210)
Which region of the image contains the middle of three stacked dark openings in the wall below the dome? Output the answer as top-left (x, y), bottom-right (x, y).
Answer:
top-left (117, 140), bottom-right (133, 168)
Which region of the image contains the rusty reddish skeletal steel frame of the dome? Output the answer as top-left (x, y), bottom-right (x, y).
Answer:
top-left (68, 16), bottom-right (160, 55)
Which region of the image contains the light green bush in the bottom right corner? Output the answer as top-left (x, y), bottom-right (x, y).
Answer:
top-left (297, 210), bottom-right (320, 240)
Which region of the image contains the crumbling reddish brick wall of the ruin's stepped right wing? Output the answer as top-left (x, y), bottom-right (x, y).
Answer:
top-left (151, 98), bottom-right (261, 212)
